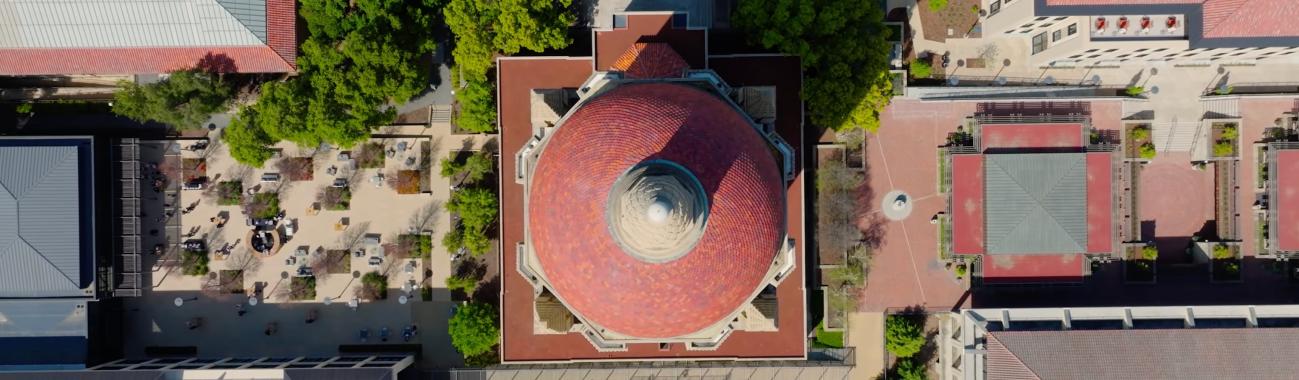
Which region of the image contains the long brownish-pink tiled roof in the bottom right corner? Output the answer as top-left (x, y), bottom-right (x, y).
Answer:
top-left (987, 328), bottom-right (1299, 379)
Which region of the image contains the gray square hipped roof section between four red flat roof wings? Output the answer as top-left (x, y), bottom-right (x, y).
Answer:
top-left (983, 153), bottom-right (1087, 254)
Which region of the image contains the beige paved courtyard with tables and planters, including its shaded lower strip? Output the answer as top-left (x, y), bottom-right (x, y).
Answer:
top-left (123, 125), bottom-right (495, 367)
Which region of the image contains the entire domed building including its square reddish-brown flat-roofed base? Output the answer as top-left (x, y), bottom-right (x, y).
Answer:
top-left (498, 14), bottom-right (807, 362)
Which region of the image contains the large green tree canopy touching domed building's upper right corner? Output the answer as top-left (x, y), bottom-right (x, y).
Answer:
top-left (733, 0), bottom-right (892, 131)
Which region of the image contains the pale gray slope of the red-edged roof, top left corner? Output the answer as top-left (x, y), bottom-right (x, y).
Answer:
top-left (0, 0), bottom-right (266, 48)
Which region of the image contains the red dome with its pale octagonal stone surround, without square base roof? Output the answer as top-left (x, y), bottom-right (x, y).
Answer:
top-left (518, 49), bottom-right (794, 350)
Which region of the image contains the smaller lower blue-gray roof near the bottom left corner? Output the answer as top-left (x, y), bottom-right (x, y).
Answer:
top-left (0, 300), bottom-right (86, 340)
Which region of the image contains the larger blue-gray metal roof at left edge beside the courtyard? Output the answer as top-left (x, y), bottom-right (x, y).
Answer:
top-left (0, 140), bottom-right (90, 298)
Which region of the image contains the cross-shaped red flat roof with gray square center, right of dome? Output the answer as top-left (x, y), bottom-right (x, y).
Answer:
top-left (950, 122), bottom-right (1115, 283)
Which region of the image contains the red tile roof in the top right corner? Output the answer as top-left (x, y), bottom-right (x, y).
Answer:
top-left (1046, 0), bottom-right (1299, 39)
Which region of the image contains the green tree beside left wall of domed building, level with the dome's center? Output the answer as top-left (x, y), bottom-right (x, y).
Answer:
top-left (452, 188), bottom-right (498, 255)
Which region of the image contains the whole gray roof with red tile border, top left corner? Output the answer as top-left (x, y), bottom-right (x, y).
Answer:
top-left (0, 0), bottom-right (297, 75)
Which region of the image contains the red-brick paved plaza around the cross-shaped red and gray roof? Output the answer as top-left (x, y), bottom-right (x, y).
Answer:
top-left (860, 99), bottom-right (1299, 311)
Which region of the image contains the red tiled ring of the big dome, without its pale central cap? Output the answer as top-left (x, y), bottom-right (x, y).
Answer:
top-left (529, 83), bottom-right (785, 338)
